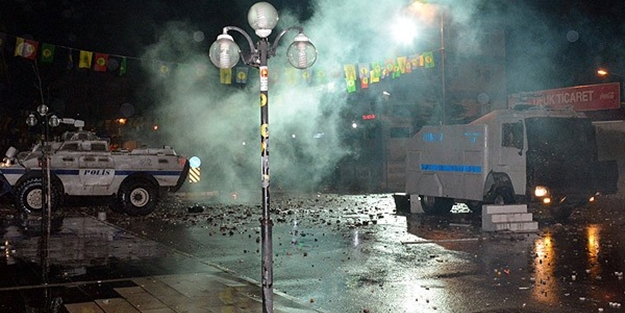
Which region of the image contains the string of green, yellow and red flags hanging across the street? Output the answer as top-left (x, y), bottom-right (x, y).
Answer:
top-left (6, 33), bottom-right (435, 93)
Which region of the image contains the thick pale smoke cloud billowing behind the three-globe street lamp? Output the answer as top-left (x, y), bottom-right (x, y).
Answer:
top-left (136, 0), bottom-right (482, 199)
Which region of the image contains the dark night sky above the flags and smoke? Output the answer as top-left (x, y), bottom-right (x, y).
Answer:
top-left (0, 0), bottom-right (625, 93)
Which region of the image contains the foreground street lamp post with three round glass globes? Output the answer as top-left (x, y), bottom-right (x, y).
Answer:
top-left (208, 2), bottom-right (317, 313)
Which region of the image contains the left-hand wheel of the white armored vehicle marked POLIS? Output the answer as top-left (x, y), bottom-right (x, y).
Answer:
top-left (15, 177), bottom-right (61, 214)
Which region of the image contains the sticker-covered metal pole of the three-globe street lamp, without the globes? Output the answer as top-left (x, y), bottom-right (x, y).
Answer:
top-left (258, 38), bottom-right (273, 313)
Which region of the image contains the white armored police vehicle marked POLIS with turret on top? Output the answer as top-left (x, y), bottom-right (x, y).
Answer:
top-left (0, 121), bottom-right (189, 215)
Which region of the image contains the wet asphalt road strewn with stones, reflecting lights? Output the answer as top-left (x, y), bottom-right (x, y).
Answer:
top-left (0, 194), bottom-right (625, 313)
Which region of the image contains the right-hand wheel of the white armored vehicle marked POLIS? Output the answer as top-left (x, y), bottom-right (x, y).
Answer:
top-left (117, 179), bottom-right (158, 216)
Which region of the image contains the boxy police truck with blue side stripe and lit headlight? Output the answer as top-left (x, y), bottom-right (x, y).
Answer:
top-left (402, 106), bottom-right (618, 219)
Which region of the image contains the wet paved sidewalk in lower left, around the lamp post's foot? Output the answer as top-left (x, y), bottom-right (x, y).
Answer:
top-left (0, 212), bottom-right (322, 313)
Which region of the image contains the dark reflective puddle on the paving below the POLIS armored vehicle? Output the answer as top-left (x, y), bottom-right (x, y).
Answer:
top-left (0, 217), bottom-right (166, 287)
